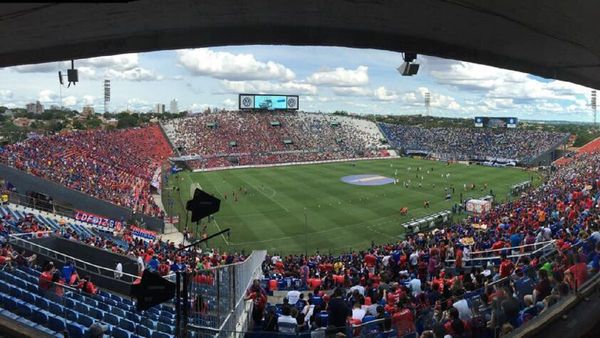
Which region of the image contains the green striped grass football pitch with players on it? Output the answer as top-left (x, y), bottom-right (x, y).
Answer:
top-left (163, 158), bottom-right (539, 254)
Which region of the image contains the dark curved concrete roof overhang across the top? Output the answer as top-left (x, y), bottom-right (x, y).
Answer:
top-left (0, 0), bottom-right (600, 89)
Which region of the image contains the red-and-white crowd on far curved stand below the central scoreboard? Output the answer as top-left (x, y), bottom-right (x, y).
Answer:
top-left (163, 111), bottom-right (381, 168)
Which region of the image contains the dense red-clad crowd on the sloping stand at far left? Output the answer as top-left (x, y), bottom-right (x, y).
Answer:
top-left (0, 125), bottom-right (172, 216)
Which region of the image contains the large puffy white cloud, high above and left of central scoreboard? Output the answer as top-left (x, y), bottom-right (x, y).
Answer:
top-left (177, 48), bottom-right (296, 81)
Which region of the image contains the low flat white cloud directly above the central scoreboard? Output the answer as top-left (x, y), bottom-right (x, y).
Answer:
top-left (222, 80), bottom-right (317, 95)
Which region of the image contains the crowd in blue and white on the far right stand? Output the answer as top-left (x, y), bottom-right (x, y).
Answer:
top-left (379, 123), bottom-right (569, 161)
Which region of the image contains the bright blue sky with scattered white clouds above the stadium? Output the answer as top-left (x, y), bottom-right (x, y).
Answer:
top-left (0, 45), bottom-right (593, 122)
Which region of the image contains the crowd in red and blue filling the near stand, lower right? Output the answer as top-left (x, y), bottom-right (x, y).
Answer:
top-left (255, 145), bottom-right (600, 337)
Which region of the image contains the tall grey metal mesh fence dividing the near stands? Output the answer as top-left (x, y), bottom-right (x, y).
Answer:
top-left (187, 251), bottom-right (267, 337)
